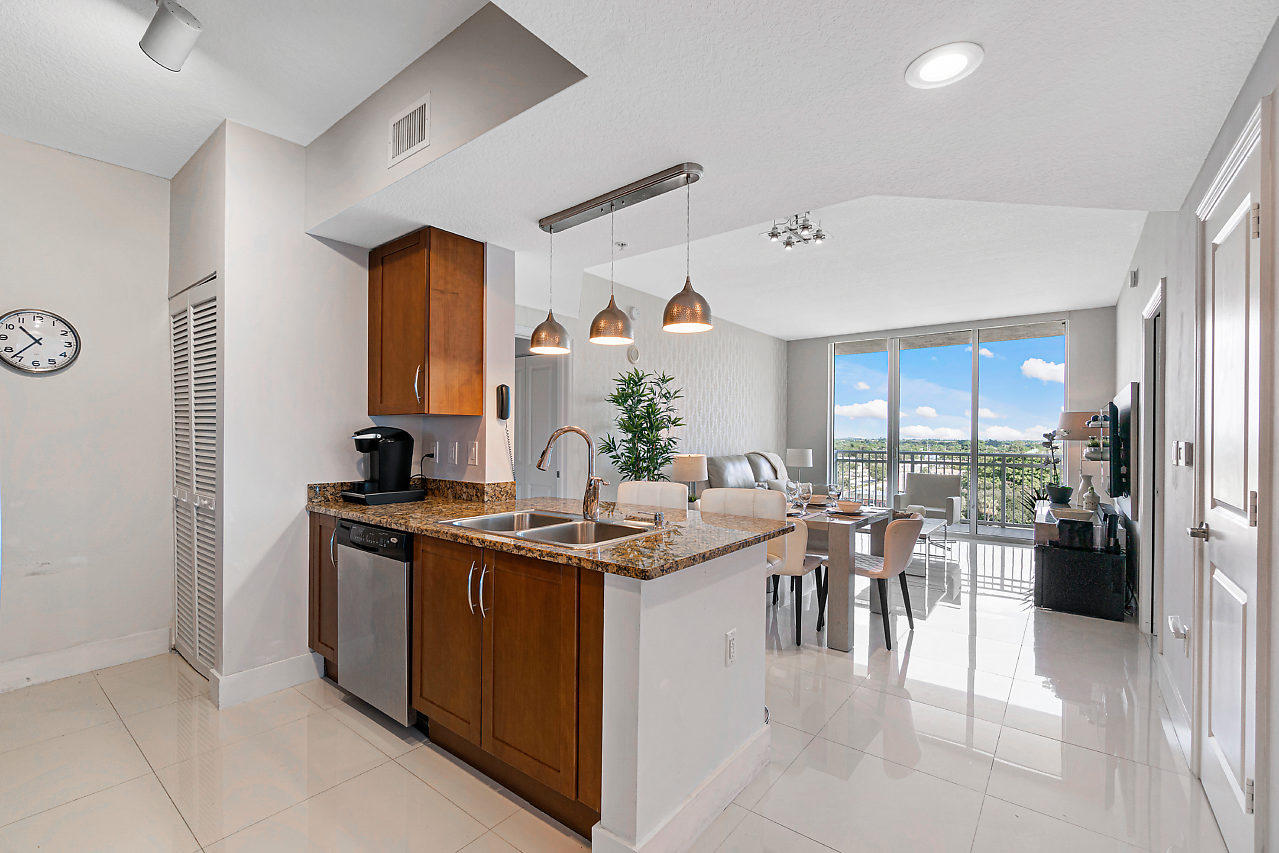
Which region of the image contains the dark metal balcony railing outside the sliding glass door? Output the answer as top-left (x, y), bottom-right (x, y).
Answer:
top-left (835, 450), bottom-right (1053, 527)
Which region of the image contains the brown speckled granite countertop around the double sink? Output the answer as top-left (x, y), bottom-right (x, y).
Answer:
top-left (307, 486), bottom-right (794, 581)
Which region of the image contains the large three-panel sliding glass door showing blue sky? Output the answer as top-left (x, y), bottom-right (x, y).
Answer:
top-left (830, 321), bottom-right (1065, 538)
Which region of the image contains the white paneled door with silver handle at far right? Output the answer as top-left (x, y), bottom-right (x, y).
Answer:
top-left (1197, 109), bottom-right (1262, 853)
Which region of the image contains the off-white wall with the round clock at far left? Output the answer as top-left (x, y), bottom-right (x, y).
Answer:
top-left (0, 136), bottom-right (173, 691)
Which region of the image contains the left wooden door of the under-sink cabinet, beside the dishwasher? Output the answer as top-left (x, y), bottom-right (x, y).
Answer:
top-left (411, 536), bottom-right (482, 746)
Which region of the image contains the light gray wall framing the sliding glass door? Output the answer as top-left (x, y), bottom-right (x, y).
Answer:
top-left (787, 308), bottom-right (1115, 485)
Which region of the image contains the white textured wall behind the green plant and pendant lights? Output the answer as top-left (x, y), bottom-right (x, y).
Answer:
top-left (517, 275), bottom-right (787, 499)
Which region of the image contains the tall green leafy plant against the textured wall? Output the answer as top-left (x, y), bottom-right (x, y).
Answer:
top-left (600, 368), bottom-right (684, 480)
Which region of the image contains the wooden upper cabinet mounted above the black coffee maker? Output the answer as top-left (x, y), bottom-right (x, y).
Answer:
top-left (368, 228), bottom-right (485, 414)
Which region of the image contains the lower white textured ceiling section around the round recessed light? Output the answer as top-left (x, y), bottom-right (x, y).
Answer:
top-left (312, 0), bottom-right (1276, 319)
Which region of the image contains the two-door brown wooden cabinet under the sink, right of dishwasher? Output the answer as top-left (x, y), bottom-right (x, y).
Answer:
top-left (411, 536), bottom-right (604, 834)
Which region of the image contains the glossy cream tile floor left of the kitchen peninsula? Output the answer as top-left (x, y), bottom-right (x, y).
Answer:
top-left (0, 655), bottom-right (587, 853)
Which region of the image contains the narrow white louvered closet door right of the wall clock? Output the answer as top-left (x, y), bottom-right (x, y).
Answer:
top-left (169, 281), bottom-right (221, 675)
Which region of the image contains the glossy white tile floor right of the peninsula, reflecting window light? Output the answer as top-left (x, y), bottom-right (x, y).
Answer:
top-left (696, 542), bottom-right (1225, 853)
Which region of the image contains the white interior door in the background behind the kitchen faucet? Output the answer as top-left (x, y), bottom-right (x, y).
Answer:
top-left (514, 356), bottom-right (564, 497)
